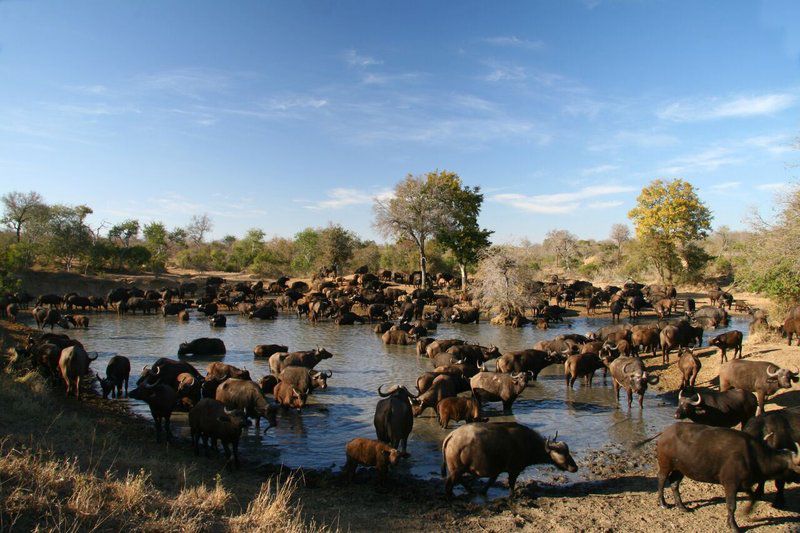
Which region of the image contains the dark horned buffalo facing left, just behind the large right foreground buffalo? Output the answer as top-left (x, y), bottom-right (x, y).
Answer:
top-left (675, 389), bottom-right (758, 428)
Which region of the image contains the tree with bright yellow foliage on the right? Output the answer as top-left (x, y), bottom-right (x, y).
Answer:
top-left (628, 179), bottom-right (711, 283)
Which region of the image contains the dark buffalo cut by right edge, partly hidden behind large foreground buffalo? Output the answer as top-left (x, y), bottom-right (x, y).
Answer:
top-left (744, 409), bottom-right (800, 508)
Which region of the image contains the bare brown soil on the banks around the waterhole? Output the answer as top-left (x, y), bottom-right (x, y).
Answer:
top-left (6, 273), bottom-right (800, 532)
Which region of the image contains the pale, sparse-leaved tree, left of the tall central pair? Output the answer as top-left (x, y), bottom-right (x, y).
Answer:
top-left (373, 171), bottom-right (452, 287)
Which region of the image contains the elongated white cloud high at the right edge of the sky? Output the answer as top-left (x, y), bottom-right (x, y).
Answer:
top-left (657, 93), bottom-right (797, 122)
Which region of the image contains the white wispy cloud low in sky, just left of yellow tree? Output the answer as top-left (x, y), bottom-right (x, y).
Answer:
top-left (491, 184), bottom-right (636, 214)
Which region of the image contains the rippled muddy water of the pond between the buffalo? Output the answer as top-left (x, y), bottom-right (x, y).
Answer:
top-left (61, 314), bottom-right (747, 490)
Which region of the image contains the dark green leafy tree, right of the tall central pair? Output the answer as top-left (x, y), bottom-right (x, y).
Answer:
top-left (436, 172), bottom-right (494, 292)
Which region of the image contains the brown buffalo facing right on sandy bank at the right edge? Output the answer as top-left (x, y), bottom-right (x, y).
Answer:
top-left (719, 359), bottom-right (798, 414)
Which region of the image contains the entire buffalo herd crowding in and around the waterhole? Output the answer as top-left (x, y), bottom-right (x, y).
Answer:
top-left (0, 268), bottom-right (800, 530)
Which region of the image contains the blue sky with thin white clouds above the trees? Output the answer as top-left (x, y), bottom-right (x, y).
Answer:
top-left (0, 0), bottom-right (800, 241)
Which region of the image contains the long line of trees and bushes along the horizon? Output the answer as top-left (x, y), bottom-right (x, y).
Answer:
top-left (0, 176), bottom-right (800, 301)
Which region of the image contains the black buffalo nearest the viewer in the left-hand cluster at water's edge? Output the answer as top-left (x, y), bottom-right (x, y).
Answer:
top-left (189, 398), bottom-right (247, 468)
